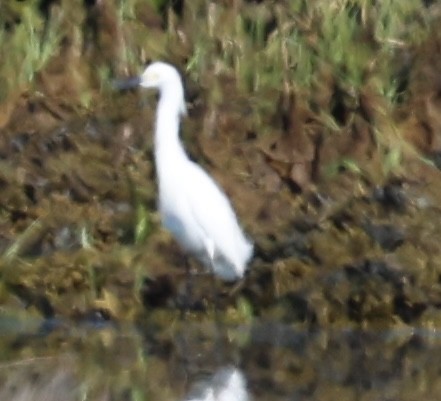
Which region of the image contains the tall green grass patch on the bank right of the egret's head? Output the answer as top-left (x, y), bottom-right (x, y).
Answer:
top-left (178, 0), bottom-right (428, 117)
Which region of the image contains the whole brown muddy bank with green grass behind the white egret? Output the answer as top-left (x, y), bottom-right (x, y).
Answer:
top-left (0, 0), bottom-right (441, 327)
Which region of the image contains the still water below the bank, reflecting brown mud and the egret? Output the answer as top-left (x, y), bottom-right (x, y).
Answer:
top-left (0, 319), bottom-right (441, 401)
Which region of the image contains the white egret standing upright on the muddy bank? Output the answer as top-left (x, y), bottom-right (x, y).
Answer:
top-left (122, 62), bottom-right (253, 281)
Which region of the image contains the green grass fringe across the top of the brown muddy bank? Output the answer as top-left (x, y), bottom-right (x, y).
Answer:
top-left (0, 0), bottom-right (435, 174)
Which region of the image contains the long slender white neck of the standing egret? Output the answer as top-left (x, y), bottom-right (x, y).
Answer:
top-left (155, 82), bottom-right (187, 176)
